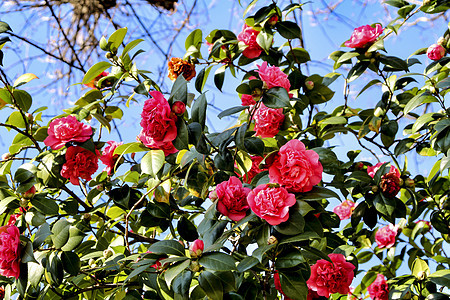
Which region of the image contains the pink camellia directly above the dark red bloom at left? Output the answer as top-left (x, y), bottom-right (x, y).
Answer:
top-left (44, 116), bottom-right (92, 150)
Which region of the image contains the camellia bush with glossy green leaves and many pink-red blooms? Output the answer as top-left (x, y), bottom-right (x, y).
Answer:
top-left (0, 0), bottom-right (450, 300)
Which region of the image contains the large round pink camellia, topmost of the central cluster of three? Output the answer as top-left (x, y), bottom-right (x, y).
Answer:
top-left (269, 140), bottom-right (323, 193)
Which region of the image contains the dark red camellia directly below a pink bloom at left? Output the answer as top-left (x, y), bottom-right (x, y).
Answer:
top-left (61, 146), bottom-right (100, 185)
